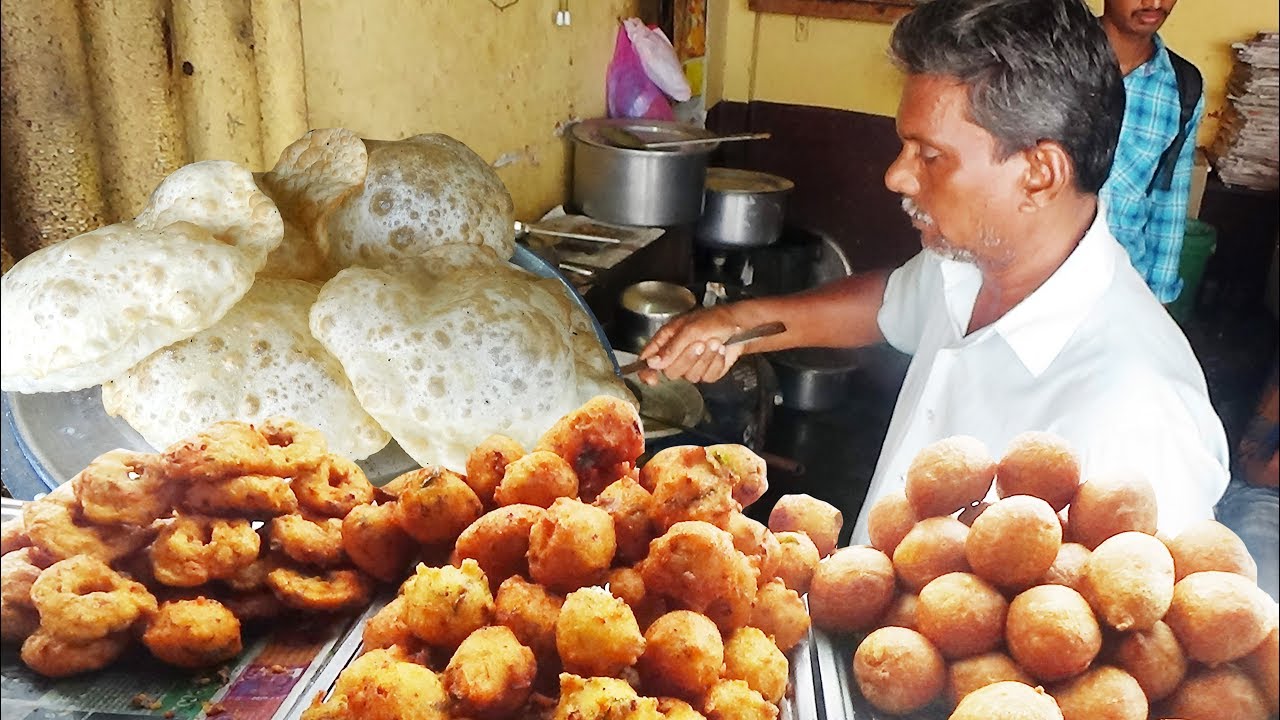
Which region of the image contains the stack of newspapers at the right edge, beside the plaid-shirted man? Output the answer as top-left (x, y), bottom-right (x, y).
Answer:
top-left (1208, 32), bottom-right (1280, 190)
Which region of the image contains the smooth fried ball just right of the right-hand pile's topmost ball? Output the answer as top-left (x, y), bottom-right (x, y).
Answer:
top-left (1068, 471), bottom-right (1156, 550)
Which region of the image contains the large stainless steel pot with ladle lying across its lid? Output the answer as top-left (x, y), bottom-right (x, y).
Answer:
top-left (571, 118), bottom-right (718, 225)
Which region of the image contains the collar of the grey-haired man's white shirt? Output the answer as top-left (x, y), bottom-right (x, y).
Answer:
top-left (942, 200), bottom-right (1119, 377)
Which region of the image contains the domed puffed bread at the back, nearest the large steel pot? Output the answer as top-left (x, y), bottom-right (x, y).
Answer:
top-left (326, 133), bottom-right (516, 268)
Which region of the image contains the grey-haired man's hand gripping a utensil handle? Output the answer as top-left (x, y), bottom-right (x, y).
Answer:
top-left (639, 305), bottom-right (742, 384)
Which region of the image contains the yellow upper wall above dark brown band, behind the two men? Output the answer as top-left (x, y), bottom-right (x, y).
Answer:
top-left (708, 0), bottom-right (1280, 145)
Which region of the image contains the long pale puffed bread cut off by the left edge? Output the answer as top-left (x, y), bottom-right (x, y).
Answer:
top-left (0, 222), bottom-right (259, 392)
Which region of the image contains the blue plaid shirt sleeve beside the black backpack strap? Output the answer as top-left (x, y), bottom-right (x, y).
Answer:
top-left (1144, 95), bottom-right (1204, 302)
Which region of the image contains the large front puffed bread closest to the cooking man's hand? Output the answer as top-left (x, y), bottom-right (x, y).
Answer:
top-left (311, 247), bottom-right (628, 471)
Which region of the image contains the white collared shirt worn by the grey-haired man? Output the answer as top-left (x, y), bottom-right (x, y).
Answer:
top-left (854, 206), bottom-right (1229, 543)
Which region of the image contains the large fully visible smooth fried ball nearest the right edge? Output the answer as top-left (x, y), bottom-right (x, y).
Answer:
top-left (1165, 570), bottom-right (1275, 666)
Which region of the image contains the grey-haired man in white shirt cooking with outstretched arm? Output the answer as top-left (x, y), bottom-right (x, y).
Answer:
top-left (641, 0), bottom-right (1228, 542)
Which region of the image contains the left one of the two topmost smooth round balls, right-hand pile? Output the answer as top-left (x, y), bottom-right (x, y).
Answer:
top-left (902, 436), bottom-right (996, 518)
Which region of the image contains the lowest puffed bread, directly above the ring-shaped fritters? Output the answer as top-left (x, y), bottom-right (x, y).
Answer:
top-left (102, 278), bottom-right (390, 460)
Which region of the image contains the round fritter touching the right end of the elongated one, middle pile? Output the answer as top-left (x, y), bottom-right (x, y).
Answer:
top-left (529, 497), bottom-right (617, 592)
